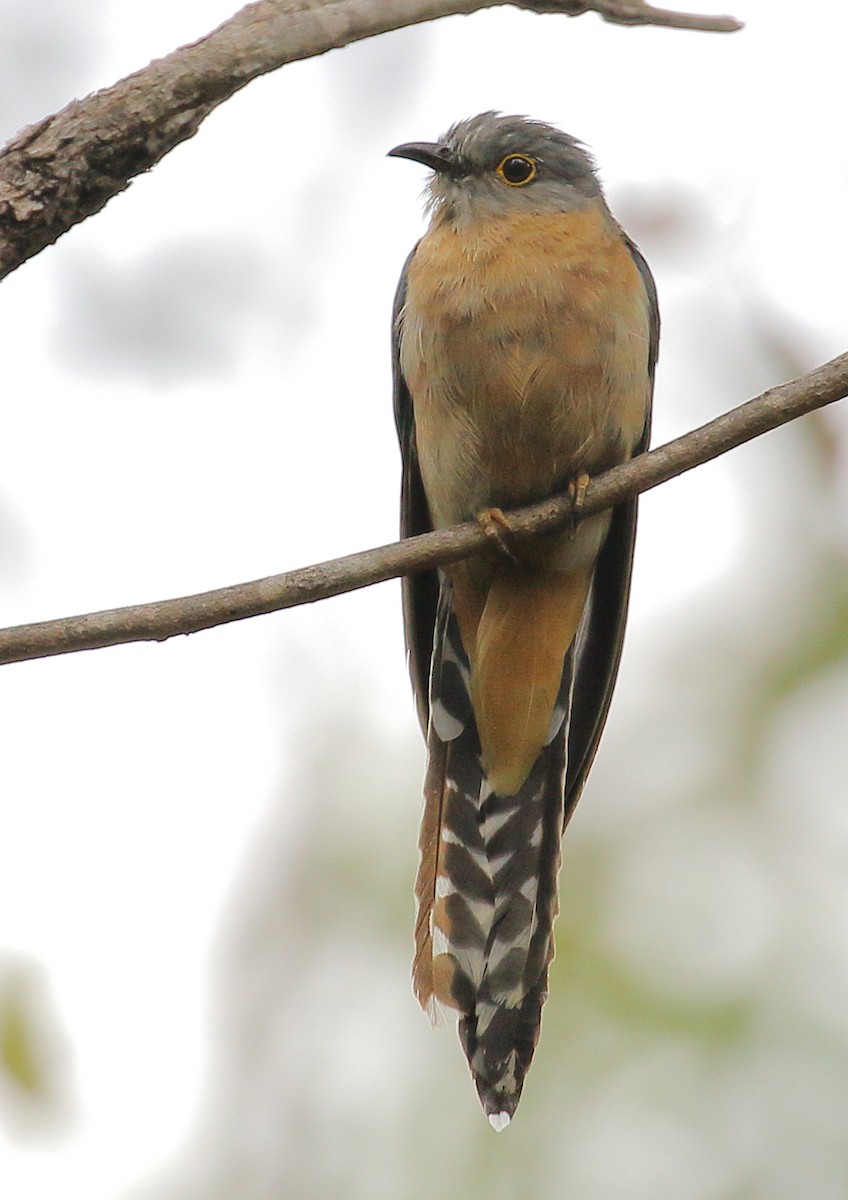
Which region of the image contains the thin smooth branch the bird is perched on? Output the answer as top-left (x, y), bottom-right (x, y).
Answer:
top-left (0, 354), bottom-right (848, 664)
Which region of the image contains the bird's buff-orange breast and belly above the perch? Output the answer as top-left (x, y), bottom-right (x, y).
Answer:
top-left (401, 206), bottom-right (649, 535)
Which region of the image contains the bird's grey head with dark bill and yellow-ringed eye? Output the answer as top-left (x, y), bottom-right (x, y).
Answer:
top-left (389, 113), bottom-right (602, 224)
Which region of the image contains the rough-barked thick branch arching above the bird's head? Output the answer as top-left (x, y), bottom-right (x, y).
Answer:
top-left (0, 0), bottom-right (740, 278)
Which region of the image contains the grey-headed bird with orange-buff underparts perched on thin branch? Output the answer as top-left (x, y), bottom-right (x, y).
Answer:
top-left (389, 112), bottom-right (660, 1130)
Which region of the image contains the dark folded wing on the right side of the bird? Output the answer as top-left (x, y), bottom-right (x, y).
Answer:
top-left (565, 234), bottom-right (660, 823)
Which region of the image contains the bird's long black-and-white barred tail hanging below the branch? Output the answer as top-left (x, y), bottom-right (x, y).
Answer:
top-left (413, 589), bottom-right (571, 1129)
